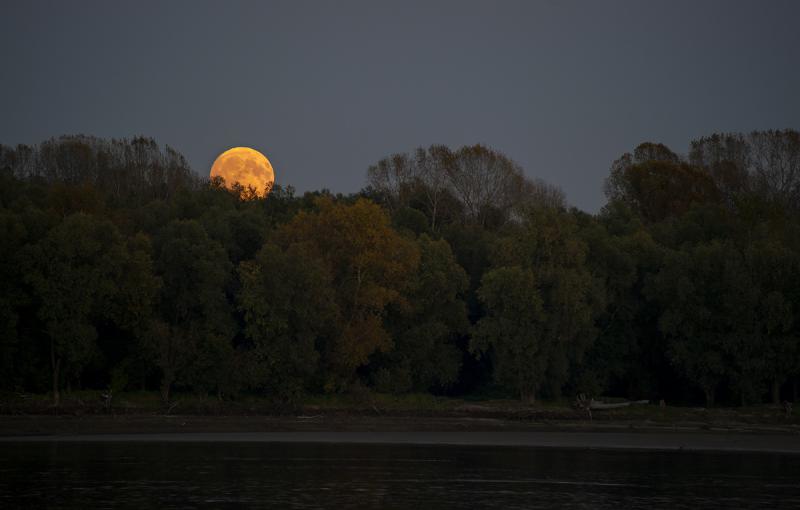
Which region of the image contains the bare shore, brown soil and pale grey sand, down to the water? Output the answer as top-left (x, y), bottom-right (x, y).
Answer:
top-left (0, 415), bottom-right (800, 454)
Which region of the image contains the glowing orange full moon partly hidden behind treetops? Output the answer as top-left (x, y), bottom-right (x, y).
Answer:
top-left (211, 147), bottom-right (275, 198)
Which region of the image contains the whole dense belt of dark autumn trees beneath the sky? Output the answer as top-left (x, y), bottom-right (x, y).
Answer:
top-left (0, 130), bottom-right (800, 406)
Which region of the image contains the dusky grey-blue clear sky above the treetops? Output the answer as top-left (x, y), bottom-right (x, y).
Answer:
top-left (0, 0), bottom-right (800, 211)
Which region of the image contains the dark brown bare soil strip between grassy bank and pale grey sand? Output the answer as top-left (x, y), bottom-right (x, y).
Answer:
top-left (0, 412), bottom-right (800, 441)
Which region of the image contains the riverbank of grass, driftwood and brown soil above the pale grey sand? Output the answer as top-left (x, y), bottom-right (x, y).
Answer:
top-left (0, 392), bottom-right (800, 437)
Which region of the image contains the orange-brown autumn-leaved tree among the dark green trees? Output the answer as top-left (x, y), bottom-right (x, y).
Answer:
top-left (281, 198), bottom-right (419, 391)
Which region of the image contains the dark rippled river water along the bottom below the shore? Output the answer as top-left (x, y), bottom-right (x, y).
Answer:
top-left (0, 442), bottom-right (800, 510)
